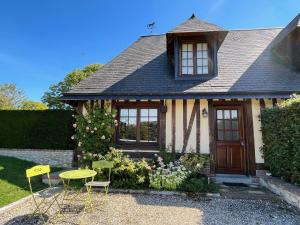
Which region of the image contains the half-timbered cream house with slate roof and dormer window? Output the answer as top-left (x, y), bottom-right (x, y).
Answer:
top-left (62, 14), bottom-right (300, 175)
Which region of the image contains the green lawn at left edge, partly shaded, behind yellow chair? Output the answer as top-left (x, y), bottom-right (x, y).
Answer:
top-left (0, 156), bottom-right (60, 207)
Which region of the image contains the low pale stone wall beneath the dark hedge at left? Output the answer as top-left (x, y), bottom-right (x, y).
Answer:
top-left (0, 148), bottom-right (74, 168)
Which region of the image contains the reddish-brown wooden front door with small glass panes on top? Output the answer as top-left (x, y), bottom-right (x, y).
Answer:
top-left (214, 106), bottom-right (246, 174)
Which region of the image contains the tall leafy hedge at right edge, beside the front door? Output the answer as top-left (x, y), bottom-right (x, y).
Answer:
top-left (261, 97), bottom-right (300, 184)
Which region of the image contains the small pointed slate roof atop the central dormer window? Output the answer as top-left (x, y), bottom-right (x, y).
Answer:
top-left (168, 14), bottom-right (225, 33)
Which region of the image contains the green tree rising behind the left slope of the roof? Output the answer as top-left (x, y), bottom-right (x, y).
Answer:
top-left (42, 64), bottom-right (102, 109)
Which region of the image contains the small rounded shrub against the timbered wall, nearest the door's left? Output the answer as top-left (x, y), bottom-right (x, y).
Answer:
top-left (180, 153), bottom-right (210, 173)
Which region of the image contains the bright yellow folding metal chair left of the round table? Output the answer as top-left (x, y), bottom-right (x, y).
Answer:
top-left (26, 165), bottom-right (61, 216)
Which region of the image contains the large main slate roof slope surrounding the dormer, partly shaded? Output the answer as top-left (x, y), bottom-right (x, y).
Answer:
top-left (62, 25), bottom-right (300, 100)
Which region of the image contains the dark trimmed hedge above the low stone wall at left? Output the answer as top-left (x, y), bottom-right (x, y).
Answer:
top-left (0, 110), bottom-right (74, 149)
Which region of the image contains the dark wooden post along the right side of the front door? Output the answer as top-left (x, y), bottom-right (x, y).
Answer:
top-left (244, 99), bottom-right (256, 176)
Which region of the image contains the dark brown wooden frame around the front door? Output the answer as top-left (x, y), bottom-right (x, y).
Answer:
top-left (208, 99), bottom-right (256, 176)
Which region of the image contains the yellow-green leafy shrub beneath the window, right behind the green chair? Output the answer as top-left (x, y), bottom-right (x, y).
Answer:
top-left (104, 148), bottom-right (151, 189)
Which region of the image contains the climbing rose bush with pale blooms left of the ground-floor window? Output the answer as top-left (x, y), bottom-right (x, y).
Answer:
top-left (71, 107), bottom-right (118, 165)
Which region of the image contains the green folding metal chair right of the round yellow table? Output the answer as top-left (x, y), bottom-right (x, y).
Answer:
top-left (86, 160), bottom-right (113, 194)
